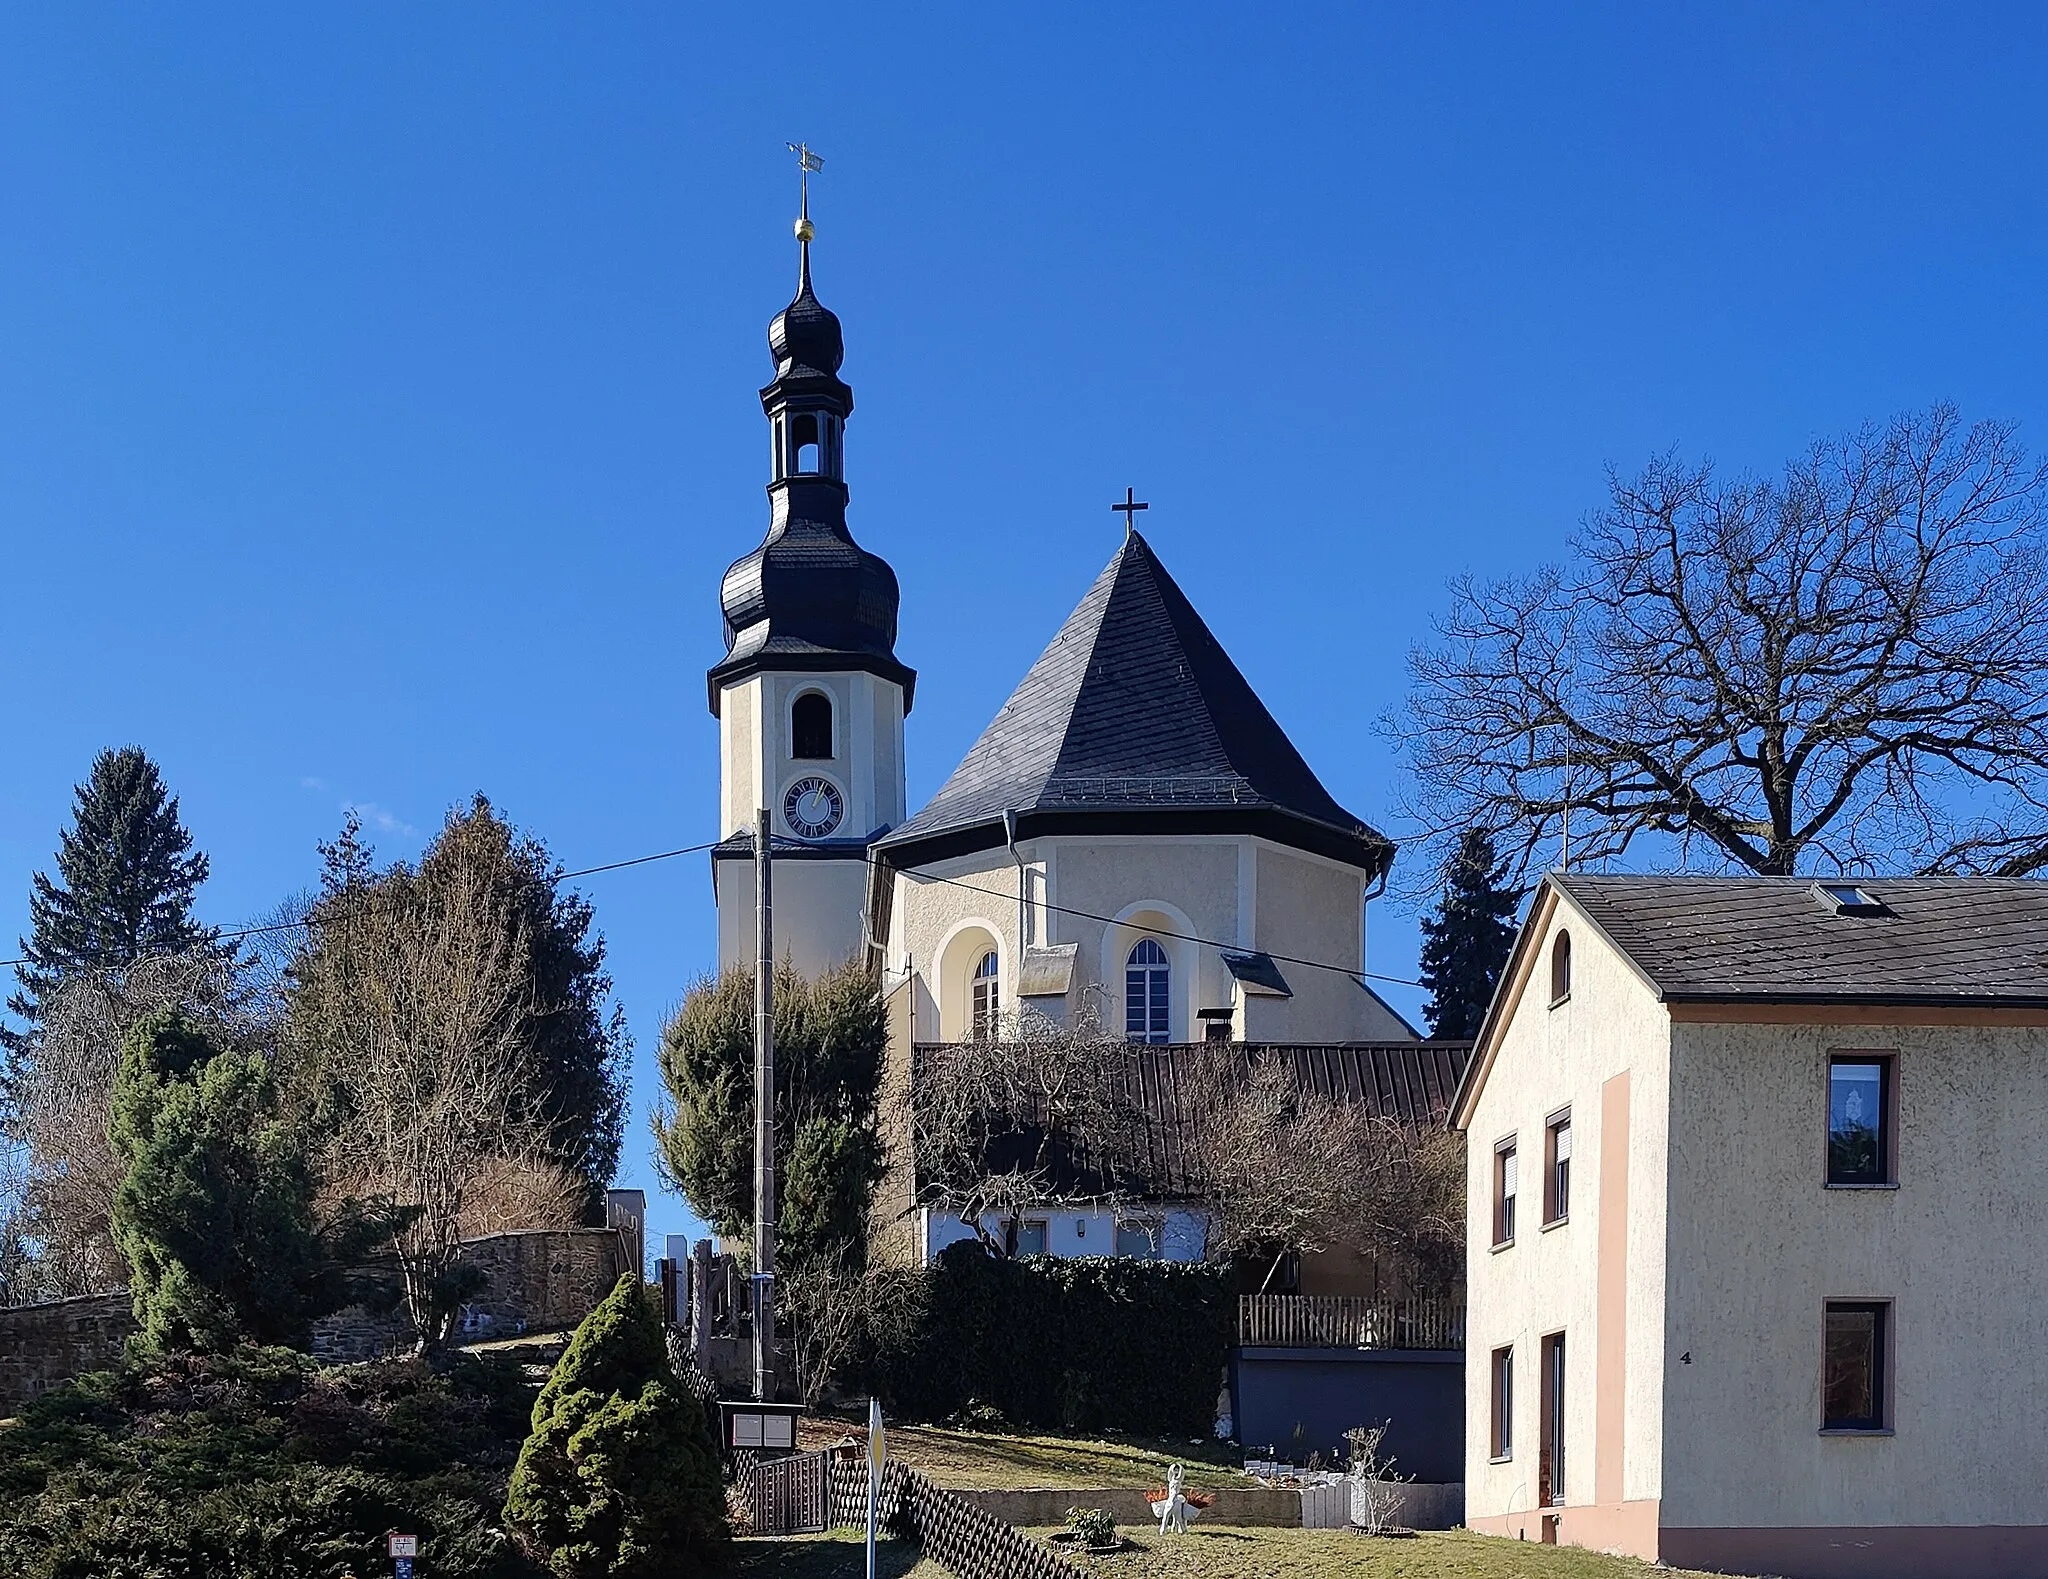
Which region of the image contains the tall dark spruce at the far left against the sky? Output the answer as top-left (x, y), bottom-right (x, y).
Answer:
top-left (0, 745), bottom-right (219, 1073)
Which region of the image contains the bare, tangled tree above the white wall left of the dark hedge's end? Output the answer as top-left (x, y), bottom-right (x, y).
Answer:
top-left (911, 1010), bottom-right (1141, 1253)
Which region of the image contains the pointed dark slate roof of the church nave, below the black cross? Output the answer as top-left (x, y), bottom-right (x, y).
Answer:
top-left (879, 532), bottom-right (1393, 872)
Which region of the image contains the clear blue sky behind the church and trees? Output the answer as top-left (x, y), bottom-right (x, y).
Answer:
top-left (0, 4), bottom-right (2048, 1253)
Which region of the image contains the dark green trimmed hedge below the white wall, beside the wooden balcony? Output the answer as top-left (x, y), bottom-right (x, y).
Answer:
top-left (864, 1243), bottom-right (1235, 1436)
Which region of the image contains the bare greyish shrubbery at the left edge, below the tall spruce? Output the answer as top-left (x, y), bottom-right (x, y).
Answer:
top-left (0, 950), bottom-right (253, 1303)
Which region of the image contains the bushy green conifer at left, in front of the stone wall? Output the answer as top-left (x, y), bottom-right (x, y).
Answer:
top-left (106, 1010), bottom-right (385, 1352)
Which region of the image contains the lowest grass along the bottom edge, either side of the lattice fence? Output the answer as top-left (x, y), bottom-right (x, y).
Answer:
top-left (733, 1526), bottom-right (1706, 1579)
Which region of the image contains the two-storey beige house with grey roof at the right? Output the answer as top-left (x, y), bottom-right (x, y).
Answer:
top-left (1452, 874), bottom-right (2048, 1579)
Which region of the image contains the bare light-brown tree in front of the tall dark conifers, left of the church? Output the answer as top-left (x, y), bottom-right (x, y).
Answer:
top-left (291, 847), bottom-right (543, 1350)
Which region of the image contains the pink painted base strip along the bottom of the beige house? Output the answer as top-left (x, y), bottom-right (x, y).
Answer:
top-left (1470, 1501), bottom-right (2048, 1579)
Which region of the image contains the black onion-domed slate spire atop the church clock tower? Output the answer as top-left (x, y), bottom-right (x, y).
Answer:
top-left (707, 240), bottom-right (918, 715)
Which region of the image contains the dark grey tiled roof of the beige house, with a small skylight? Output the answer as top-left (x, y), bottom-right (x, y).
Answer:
top-left (1548, 872), bottom-right (2048, 1006)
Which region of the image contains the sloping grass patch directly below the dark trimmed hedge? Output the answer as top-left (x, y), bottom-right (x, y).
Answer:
top-left (803, 1417), bottom-right (1255, 1491)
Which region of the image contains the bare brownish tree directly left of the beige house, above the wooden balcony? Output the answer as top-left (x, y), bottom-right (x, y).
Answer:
top-left (1184, 1049), bottom-right (1464, 1278)
